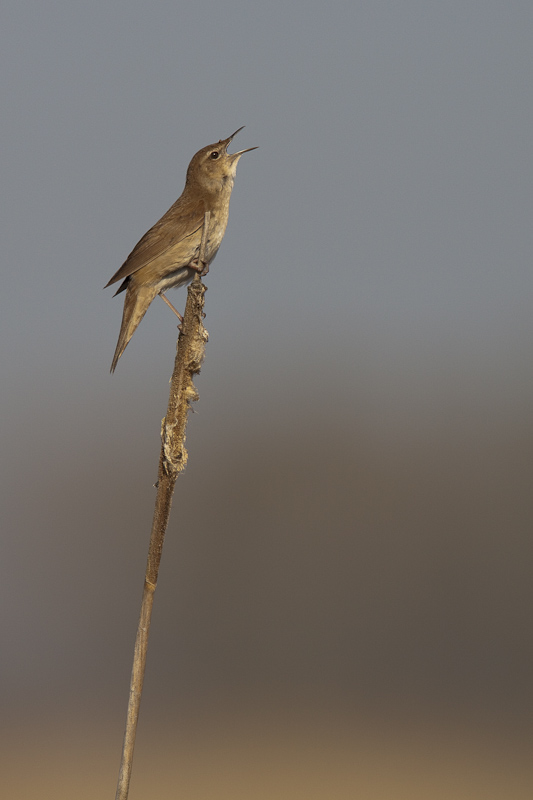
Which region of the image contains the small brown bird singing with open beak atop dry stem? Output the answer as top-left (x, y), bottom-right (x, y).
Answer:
top-left (104, 128), bottom-right (257, 372)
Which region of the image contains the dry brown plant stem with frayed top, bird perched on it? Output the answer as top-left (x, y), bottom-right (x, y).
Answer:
top-left (115, 212), bottom-right (209, 800)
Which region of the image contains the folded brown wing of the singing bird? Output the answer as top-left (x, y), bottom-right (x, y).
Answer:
top-left (104, 197), bottom-right (204, 289)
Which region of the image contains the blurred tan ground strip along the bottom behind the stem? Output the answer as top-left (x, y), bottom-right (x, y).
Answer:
top-left (2, 708), bottom-right (533, 800)
